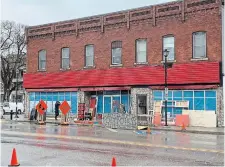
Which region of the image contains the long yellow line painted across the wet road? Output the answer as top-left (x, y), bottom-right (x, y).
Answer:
top-left (1, 131), bottom-right (224, 154)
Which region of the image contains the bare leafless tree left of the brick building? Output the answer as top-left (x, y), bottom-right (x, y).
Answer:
top-left (0, 21), bottom-right (26, 101)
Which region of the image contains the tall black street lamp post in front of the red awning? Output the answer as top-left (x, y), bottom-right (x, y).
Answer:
top-left (164, 49), bottom-right (169, 126)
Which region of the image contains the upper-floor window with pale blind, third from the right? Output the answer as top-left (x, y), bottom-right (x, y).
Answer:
top-left (136, 39), bottom-right (147, 63)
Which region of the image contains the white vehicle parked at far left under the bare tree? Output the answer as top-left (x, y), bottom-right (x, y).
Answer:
top-left (3, 102), bottom-right (24, 114)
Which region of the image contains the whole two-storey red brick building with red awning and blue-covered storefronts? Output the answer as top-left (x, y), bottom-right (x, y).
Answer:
top-left (24, 0), bottom-right (224, 126)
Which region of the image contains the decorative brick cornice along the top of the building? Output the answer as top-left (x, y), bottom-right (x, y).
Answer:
top-left (26, 0), bottom-right (221, 39)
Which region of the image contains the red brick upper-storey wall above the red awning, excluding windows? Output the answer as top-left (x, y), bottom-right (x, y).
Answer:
top-left (27, 0), bottom-right (222, 73)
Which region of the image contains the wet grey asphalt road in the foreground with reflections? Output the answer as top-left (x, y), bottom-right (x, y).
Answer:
top-left (1, 121), bottom-right (224, 166)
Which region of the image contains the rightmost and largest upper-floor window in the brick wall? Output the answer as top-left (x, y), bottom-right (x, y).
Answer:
top-left (193, 32), bottom-right (206, 59)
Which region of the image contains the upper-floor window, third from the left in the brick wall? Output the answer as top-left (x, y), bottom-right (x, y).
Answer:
top-left (85, 45), bottom-right (94, 67)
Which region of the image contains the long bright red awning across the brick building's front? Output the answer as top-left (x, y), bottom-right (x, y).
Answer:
top-left (24, 62), bottom-right (220, 89)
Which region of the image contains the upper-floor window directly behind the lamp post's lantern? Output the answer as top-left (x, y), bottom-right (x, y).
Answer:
top-left (163, 36), bottom-right (175, 61)
